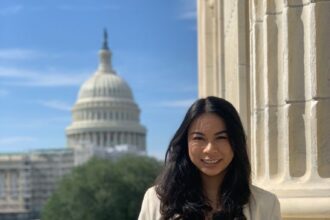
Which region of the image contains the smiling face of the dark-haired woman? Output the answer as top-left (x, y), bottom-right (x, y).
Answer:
top-left (188, 113), bottom-right (234, 178)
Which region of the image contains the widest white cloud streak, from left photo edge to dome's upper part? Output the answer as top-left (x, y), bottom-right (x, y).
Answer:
top-left (0, 66), bottom-right (90, 87)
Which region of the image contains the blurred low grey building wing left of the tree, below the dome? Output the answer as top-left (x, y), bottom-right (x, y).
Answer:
top-left (0, 149), bottom-right (74, 220)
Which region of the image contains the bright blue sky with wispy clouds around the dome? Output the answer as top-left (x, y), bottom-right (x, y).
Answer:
top-left (0, 0), bottom-right (197, 158)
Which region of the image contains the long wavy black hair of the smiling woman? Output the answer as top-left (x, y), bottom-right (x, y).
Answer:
top-left (156, 96), bottom-right (251, 220)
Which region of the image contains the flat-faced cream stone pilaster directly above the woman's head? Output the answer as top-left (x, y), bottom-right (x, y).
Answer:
top-left (197, 0), bottom-right (250, 145)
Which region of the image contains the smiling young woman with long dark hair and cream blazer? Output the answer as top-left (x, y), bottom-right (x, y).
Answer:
top-left (139, 97), bottom-right (281, 220)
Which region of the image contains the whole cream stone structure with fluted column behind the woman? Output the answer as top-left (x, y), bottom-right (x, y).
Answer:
top-left (197, 0), bottom-right (330, 219)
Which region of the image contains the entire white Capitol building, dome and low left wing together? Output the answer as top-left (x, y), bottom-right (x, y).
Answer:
top-left (0, 31), bottom-right (146, 220)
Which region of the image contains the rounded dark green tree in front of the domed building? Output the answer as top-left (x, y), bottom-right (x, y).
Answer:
top-left (42, 155), bottom-right (162, 220)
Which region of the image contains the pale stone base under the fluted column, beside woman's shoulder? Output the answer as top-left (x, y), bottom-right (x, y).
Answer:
top-left (255, 178), bottom-right (330, 220)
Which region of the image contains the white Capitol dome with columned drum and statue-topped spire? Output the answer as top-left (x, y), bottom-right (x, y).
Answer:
top-left (66, 32), bottom-right (146, 151)
